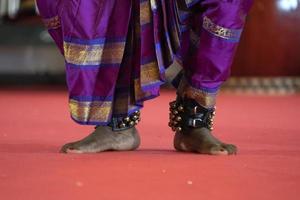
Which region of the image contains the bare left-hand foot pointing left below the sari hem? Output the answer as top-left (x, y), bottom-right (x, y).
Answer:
top-left (60, 126), bottom-right (140, 153)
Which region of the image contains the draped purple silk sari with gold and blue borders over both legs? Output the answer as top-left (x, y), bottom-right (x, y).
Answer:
top-left (37, 0), bottom-right (252, 125)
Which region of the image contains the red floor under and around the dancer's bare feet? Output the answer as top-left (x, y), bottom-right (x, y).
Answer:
top-left (0, 89), bottom-right (300, 200)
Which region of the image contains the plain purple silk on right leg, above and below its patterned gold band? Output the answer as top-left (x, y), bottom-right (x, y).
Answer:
top-left (181, 0), bottom-right (252, 92)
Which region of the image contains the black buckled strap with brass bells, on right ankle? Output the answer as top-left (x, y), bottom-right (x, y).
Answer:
top-left (169, 98), bottom-right (215, 132)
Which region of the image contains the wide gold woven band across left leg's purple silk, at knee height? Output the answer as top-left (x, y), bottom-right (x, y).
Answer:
top-left (64, 42), bottom-right (125, 65)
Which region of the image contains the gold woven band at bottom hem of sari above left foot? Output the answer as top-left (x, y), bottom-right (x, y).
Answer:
top-left (69, 99), bottom-right (112, 122)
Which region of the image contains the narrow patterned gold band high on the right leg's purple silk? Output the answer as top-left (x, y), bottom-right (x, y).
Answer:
top-left (203, 16), bottom-right (241, 40)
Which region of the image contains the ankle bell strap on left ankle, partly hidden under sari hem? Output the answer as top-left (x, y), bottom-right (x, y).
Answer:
top-left (109, 111), bottom-right (141, 131)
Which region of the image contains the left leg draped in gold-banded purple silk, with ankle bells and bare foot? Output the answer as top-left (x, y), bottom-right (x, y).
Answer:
top-left (37, 0), bottom-right (166, 153)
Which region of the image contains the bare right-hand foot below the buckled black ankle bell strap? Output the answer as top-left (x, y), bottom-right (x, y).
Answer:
top-left (174, 128), bottom-right (237, 155)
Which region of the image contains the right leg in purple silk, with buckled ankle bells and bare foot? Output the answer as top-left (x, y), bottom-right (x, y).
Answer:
top-left (170, 0), bottom-right (251, 155)
